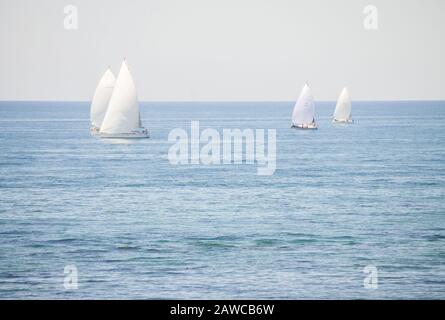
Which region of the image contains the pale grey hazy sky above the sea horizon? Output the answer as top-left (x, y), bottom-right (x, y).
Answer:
top-left (0, 0), bottom-right (445, 101)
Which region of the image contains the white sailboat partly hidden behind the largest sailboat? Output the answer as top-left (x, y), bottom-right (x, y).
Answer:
top-left (90, 68), bottom-right (116, 134)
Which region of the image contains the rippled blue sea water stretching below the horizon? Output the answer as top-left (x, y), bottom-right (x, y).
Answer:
top-left (0, 102), bottom-right (445, 299)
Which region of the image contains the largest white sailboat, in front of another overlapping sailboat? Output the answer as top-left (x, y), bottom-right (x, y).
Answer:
top-left (99, 60), bottom-right (149, 139)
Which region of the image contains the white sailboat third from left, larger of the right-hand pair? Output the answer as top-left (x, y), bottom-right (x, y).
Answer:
top-left (292, 83), bottom-right (317, 129)
